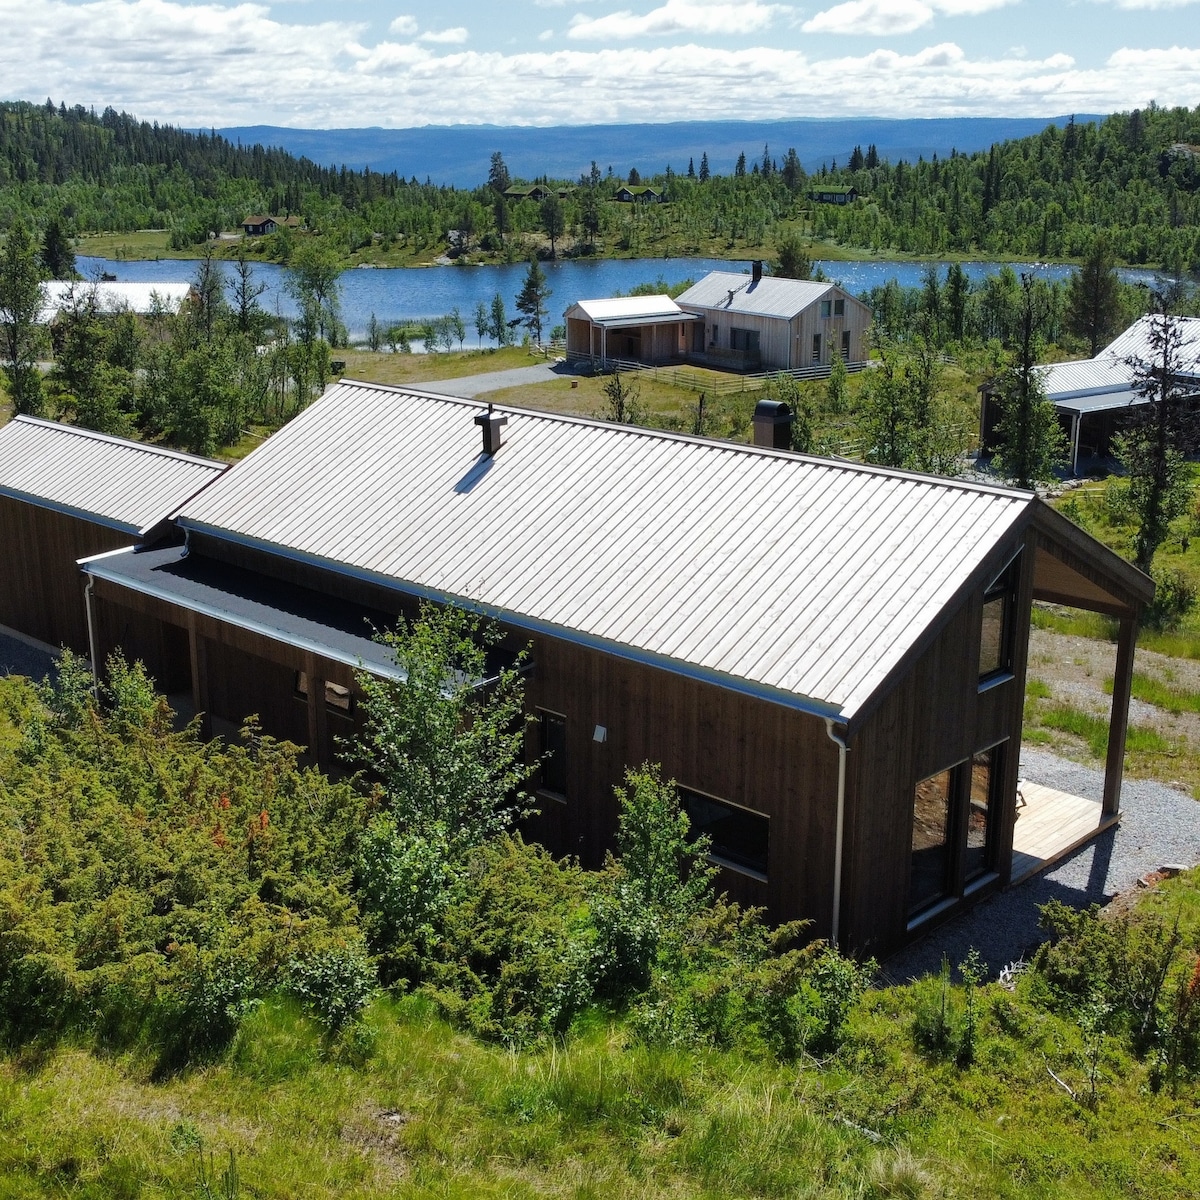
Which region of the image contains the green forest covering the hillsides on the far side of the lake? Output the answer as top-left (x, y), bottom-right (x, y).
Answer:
top-left (0, 101), bottom-right (1200, 271)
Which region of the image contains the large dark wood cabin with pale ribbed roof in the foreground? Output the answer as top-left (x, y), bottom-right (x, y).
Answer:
top-left (0, 382), bottom-right (1153, 954)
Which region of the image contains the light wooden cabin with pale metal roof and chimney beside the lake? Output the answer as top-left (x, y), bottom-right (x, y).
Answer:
top-left (566, 263), bottom-right (871, 371)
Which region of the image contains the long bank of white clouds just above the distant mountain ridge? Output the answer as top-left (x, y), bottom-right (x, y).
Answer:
top-left (0, 0), bottom-right (1185, 127)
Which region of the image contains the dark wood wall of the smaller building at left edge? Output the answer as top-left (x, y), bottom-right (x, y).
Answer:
top-left (0, 496), bottom-right (137, 654)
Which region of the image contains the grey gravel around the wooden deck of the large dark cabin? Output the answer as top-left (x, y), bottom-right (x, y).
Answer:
top-left (883, 746), bottom-right (1200, 983)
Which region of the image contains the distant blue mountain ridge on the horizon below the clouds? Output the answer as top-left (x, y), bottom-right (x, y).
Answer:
top-left (216, 114), bottom-right (1104, 187)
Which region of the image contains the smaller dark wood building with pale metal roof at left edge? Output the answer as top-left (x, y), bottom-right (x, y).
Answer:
top-left (0, 416), bottom-right (223, 654)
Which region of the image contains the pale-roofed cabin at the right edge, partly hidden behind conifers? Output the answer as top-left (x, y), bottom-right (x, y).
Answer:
top-left (979, 316), bottom-right (1200, 475)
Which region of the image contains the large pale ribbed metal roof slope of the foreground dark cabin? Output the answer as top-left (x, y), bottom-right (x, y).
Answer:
top-left (179, 382), bottom-right (1033, 719)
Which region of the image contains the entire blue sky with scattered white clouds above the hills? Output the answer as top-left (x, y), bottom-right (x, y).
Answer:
top-left (0, 0), bottom-right (1200, 128)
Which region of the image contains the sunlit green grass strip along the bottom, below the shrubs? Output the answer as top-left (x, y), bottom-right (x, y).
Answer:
top-left (0, 872), bottom-right (1200, 1200)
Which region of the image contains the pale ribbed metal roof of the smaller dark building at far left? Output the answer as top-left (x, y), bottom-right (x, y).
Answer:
top-left (0, 416), bottom-right (226, 534)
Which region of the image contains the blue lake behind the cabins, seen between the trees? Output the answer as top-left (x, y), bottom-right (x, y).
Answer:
top-left (78, 254), bottom-right (1156, 346)
